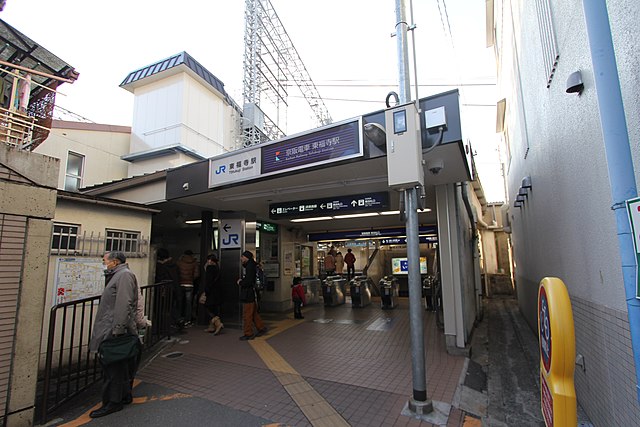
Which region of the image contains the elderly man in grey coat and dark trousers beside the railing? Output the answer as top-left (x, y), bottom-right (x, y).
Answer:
top-left (89, 251), bottom-right (139, 418)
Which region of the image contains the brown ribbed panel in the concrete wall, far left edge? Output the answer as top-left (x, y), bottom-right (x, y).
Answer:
top-left (0, 214), bottom-right (27, 417)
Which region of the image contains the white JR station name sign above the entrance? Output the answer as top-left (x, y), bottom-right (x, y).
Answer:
top-left (209, 148), bottom-right (260, 188)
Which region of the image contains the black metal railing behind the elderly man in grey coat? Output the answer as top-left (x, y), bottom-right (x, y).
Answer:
top-left (40, 282), bottom-right (172, 423)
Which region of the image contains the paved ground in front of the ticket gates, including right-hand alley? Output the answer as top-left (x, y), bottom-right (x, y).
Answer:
top-left (40, 299), bottom-right (588, 427)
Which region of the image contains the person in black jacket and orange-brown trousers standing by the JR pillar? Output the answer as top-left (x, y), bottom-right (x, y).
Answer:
top-left (238, 251), bottom-right (267, 341)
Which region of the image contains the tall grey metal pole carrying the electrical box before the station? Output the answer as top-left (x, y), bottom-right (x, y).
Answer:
top-left (396, 0), bottom-right (433, 414)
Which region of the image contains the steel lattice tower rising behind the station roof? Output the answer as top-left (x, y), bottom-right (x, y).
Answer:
top-left (241, 0), bottom-right (331, 147)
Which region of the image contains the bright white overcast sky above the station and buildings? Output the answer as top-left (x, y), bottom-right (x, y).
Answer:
top-left (0, 0), bottom-right (504, 201)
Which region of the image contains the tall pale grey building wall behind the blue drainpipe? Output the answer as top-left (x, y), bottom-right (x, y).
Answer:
top-left (495, 0), bottom-right (640, 425)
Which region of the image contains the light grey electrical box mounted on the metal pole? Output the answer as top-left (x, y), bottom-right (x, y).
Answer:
top-left (385, 102), bottom-right (424, 190)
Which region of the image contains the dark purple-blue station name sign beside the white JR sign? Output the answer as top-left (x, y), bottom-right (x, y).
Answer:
top-left (261, 120), bottom-right (363, 175)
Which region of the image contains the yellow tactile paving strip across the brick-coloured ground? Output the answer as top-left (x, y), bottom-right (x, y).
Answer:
top-left (249, 319), bottom-right (349, 427)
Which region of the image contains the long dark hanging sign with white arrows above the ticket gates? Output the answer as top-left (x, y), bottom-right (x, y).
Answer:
top-left (269, 193), bottom-right (389, 219)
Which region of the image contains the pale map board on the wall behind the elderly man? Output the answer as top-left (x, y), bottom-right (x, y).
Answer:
top-left (53, 258), bottom-right (105, 304)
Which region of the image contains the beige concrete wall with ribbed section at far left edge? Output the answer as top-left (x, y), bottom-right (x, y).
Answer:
top-left (0, 145), bottom-right (59, 426)
